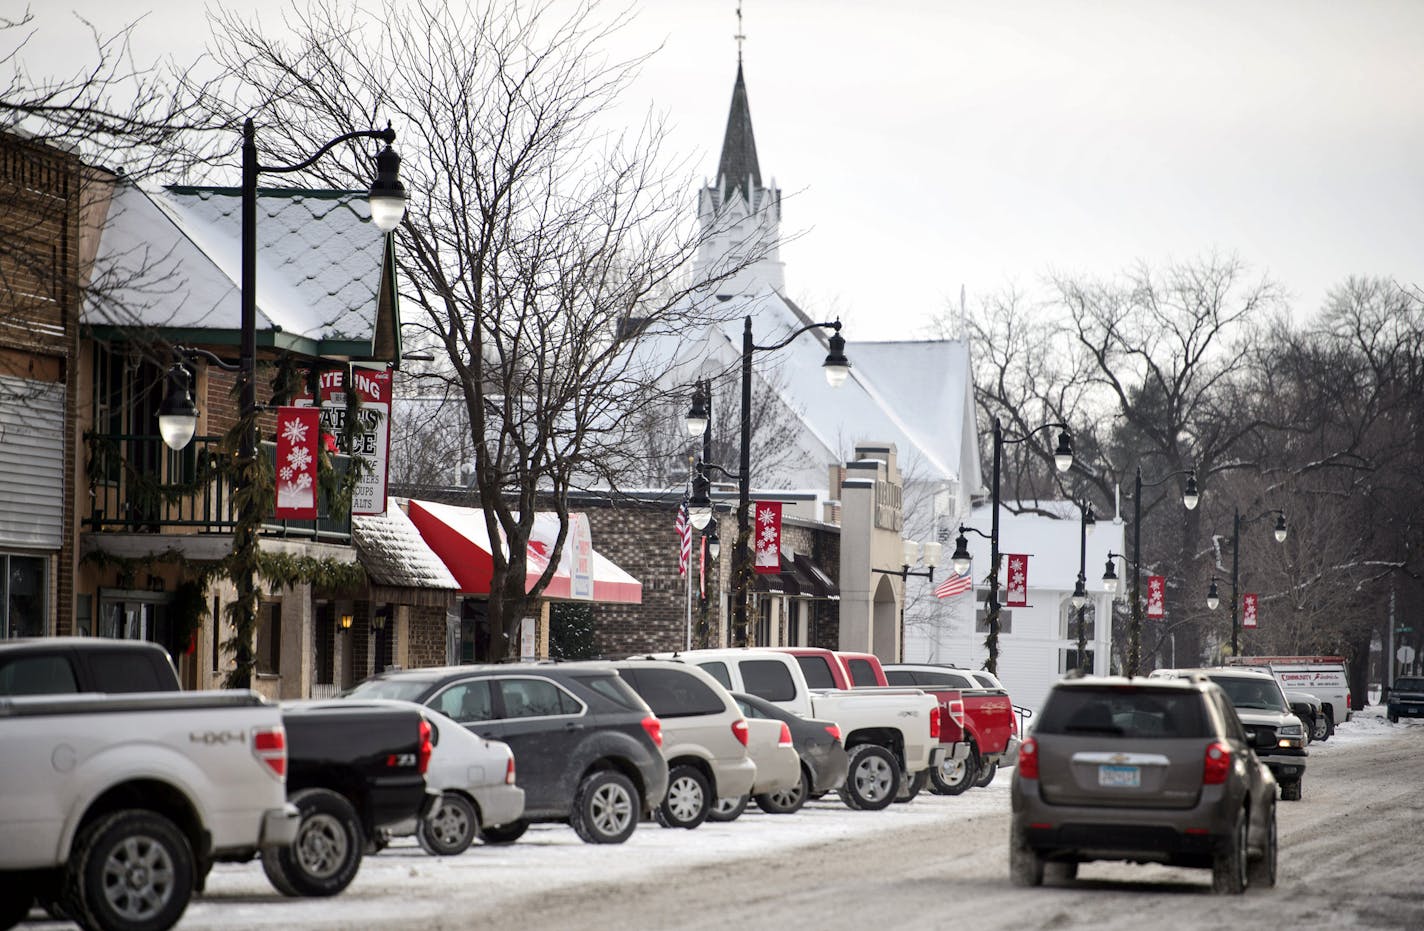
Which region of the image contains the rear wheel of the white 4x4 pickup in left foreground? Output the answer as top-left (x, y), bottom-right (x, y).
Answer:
top-left (62, 810), bottom-right (197, 931)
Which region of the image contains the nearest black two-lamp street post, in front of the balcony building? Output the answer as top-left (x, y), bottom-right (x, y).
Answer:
top-left (158, 118), bottom-right (406, 689)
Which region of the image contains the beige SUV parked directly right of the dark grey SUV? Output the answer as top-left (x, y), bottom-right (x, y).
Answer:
top-left (614, 659), bottom-right (756, 829)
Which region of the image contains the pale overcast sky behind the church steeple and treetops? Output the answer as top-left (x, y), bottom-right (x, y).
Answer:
top-left (19, 0), bottom-right (1424, 339)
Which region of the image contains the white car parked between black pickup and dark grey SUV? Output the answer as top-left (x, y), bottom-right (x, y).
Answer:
top-left (358, 708), bottom-right (524, 857)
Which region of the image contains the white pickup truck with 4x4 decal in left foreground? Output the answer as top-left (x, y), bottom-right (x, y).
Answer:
top-left (0, 692), bottom-right (299, 931)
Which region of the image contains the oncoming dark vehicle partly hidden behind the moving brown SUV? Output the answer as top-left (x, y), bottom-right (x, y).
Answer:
top-left (1152, 666), bottom-right (1310, 801)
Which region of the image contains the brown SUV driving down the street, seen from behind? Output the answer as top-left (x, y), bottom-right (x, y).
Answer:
top-left (1008, 675), bottom-right (1276, 894)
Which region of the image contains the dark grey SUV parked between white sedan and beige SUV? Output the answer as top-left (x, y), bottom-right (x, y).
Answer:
top-left (347, 663), bottom-right (668, 844)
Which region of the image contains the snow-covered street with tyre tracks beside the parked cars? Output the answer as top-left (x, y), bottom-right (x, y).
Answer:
top-left (23, 708), bottom-right (1424, 931)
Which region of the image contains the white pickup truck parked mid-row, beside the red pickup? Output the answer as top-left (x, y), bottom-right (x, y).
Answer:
top-left (649, 648), bottom-right (944, 811)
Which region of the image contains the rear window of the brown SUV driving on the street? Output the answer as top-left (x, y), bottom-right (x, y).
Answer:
top-left (1034, 688), bottom-right (1206, 739)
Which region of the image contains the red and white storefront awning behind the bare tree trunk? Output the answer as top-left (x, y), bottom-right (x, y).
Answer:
top-left (409, 500), bottom-right (642, 605)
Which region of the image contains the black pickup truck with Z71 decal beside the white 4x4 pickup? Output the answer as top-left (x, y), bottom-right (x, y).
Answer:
top-left (262, 708), bottom-right (439, 895)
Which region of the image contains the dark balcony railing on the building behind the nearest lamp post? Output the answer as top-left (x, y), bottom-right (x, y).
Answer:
top-left (83, 433), bottom-right (350, 542)
